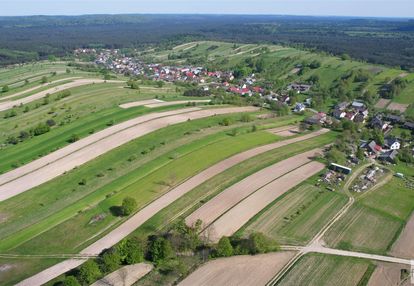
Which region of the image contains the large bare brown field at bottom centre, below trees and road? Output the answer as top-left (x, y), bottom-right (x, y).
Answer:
top-left (178, 252), bottom-right (295, 286)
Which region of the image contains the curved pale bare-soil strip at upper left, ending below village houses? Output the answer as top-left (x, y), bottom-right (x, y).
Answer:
top-left (0, 79), bottom-right (123, 111)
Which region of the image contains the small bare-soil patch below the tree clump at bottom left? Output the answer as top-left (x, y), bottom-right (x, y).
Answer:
top-left (92, 263), bottom-right (153, 286)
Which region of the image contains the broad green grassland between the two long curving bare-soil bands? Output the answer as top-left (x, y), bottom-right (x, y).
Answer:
top-left (0, 111), bottom-right (278, 252)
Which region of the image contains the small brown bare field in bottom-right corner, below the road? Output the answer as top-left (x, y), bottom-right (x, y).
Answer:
top-left (367, 263), bottom-right (409, 286)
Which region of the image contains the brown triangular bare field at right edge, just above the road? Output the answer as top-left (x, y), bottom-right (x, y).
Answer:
top-left (391, 214), bottom-right (414, 259)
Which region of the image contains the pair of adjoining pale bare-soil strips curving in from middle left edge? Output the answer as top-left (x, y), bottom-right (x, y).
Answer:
top-left (0, 107), bottom-right (258, 201)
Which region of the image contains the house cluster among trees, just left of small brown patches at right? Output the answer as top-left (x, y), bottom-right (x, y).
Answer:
top-left (332, 101), bottom-right (369, 123)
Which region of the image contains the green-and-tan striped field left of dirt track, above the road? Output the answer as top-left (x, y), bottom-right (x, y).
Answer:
top-left (244, 184), bottom-right (347, 245)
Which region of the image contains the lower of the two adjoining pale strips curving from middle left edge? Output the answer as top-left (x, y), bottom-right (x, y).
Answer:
top-left (0, 107), bottom-right (257, 201)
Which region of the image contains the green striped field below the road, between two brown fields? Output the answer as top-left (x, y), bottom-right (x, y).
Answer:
top-left (276, 254), bottom-right (372, 286)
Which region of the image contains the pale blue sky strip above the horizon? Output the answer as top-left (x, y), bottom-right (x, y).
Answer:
top-left (0, 0), bottom-right (414, 18)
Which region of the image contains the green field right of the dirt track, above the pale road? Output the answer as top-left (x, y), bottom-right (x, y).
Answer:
top-left (324, 178), bottom-right (414, 254)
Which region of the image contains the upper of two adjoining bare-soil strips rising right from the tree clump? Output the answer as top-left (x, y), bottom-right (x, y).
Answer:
top-left (186, 149), bottom-right (320, 227)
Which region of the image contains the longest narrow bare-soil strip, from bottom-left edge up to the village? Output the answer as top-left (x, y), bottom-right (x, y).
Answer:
top-left (13, 129), bottom-right (329, 286)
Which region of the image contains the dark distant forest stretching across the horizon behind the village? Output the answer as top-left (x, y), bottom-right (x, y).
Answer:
top-left (0, 15), bottom-right (414, 69)
